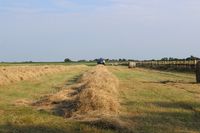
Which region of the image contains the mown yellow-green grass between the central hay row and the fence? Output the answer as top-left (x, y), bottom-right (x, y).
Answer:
top-left (109, 67), bottom-right (200, 133)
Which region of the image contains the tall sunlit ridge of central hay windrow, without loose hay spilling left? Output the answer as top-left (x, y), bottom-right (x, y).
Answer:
top-left (73, 65), bottom-right (119, 118)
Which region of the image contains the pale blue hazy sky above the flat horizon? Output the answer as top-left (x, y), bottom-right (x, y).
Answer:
top-left (0, 0), bottom-right (200, 62)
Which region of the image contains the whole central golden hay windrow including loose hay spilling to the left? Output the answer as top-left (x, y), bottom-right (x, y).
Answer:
top-left (33, 65), bottom-right (131, 130)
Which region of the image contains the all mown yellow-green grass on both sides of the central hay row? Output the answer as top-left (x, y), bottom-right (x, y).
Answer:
top-left (0, 66), bottom-right (200, 133)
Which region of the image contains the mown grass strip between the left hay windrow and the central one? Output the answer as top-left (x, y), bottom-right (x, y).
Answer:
top-left (0, 67), bottom-right (111, 133)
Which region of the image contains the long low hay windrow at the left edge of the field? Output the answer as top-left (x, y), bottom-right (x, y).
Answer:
top-left (0, 65), bottom-right (85, 85)
